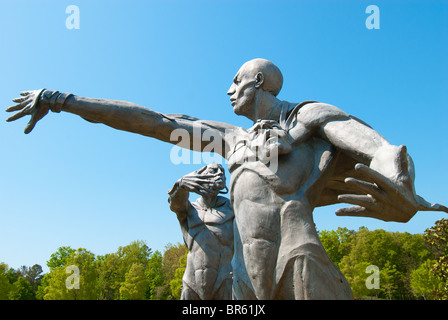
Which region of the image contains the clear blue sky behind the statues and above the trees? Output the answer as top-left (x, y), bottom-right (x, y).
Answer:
top-left (0, 0), bottom-right (448, 268)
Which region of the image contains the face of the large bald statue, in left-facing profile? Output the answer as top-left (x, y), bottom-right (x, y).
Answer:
top-left (227, 65), bottom-right (257, 119)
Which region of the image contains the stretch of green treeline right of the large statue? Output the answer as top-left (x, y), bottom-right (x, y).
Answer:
top-left (319, 219), bottom-right (448, 300)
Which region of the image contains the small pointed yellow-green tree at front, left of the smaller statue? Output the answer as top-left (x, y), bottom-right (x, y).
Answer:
top-left (120, 263), bottom-right (149, 300)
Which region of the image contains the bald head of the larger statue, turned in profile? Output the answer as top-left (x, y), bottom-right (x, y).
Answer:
top-left (227, 59), bottom-right (283, 120)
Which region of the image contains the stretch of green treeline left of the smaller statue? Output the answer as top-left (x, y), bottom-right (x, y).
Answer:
top-left (0, 240), bottom-right (187, 300)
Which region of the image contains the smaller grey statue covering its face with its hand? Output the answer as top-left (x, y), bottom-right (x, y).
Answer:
top-left (168, 163), bottom-right (234, 300)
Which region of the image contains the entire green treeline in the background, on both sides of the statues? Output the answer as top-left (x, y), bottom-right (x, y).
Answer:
top-left (0, 219), bottom-right (448, 300)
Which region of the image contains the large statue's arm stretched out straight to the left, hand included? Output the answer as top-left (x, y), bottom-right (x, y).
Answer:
top-left (6, 90), bottom-right (236, 156)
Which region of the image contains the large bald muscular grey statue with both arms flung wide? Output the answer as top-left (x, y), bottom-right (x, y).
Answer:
top-left (7, 59), bottom-right (448, 299)
